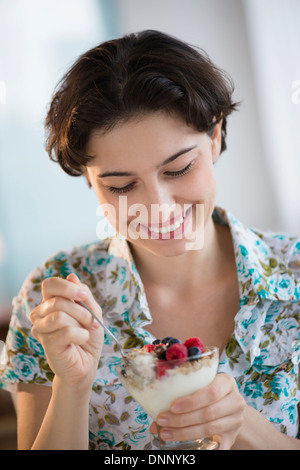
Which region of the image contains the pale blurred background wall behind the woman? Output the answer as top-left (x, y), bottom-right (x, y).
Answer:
top-left (0, 0), bottom-right (300, 322)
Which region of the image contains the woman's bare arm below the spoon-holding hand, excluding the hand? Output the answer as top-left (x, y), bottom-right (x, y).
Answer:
top-left (18, 379), bottom-right (89, 450)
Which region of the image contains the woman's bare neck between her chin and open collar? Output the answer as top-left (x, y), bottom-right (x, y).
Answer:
top-left (131, 218), bottom-right (224, 290)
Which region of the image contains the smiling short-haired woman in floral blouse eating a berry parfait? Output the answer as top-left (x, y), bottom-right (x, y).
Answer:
top-left (2, 31), bottom-right (300, 449)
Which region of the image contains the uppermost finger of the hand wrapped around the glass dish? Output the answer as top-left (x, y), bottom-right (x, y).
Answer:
top-left (170, 374), bottom-right (237, 413)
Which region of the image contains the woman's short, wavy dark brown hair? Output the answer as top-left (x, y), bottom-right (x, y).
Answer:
top-left (45, 30), bottom-right (237, 176)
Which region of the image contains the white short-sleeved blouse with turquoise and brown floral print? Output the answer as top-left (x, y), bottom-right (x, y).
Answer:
top-left (0, 208), bottom-right (300, 450)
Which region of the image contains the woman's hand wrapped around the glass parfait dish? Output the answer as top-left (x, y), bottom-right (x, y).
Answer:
top-left (150, 374), bottom-right (246, 450)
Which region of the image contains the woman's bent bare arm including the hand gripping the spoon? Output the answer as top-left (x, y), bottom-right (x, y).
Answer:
top-left (17, 275), bottom-right (103, 450)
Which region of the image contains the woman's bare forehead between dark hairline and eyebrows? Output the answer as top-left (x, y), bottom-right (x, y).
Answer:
top-left (87, 113), bottom-right (201, 166)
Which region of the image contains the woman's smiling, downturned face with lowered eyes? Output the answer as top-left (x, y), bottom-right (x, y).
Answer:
top-left (86, 112), bottom-right (221, 256)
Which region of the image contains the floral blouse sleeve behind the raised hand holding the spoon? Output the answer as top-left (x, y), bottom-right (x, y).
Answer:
top-left (0, 241), bottom-right (108, 392)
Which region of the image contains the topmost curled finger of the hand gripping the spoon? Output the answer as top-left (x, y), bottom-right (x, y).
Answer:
top-left (42, 277), bottom-right (87, 301)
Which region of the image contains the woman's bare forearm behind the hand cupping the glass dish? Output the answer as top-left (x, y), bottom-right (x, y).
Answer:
top-left (231, 406), bottom-right (300, 450)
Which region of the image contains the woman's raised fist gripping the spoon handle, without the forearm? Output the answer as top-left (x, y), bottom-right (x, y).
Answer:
top-left (30, 274), bottom-right (103, 391)
